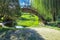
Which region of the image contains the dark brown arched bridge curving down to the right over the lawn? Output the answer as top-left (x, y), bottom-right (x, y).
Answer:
top-left (21, 8), bottom-right (47, 24)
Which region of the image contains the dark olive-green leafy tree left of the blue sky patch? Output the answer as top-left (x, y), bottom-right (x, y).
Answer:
top-left (0, 0), bottom-right (21, 24)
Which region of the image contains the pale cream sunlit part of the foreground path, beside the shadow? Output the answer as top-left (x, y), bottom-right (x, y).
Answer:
top-left (31, 28), bottom-right (60, 40)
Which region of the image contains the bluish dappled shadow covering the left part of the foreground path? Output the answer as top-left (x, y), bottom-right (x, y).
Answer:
top-left (0, 28), bottom-right (44, 40)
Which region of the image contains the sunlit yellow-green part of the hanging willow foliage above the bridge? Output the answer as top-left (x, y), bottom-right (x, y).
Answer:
top-left (32, 0), bottom-right (52, 20)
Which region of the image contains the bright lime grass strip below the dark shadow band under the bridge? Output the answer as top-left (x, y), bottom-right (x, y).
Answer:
top-left (17, 20), bottom-right (38, 26)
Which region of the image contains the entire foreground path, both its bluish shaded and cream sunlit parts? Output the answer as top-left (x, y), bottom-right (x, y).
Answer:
top-left (0, 27), bottom-right (60, 40)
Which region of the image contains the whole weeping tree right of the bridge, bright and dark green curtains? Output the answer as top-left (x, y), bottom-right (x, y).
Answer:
top-left (32, 0), bottom-right (60, 21)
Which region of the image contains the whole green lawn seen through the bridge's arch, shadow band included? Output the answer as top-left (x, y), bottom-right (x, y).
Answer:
top-left (17, 13), bottom-right (39, 26)
